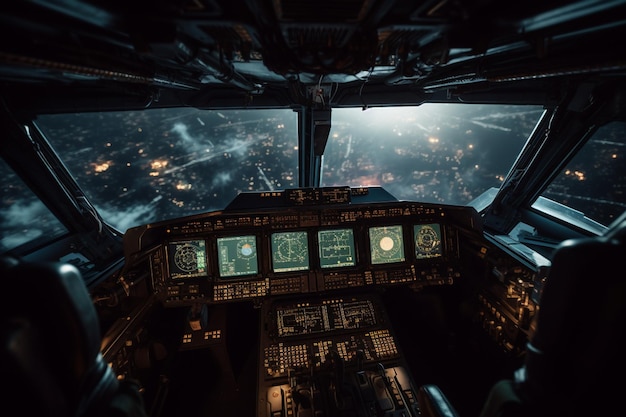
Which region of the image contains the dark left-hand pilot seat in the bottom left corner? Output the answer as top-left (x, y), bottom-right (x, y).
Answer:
top-left (0, 256), bottom-right (143, 417)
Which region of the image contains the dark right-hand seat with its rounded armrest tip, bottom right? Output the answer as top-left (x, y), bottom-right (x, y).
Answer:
top-left (418, 213), bottom-right (626, 417)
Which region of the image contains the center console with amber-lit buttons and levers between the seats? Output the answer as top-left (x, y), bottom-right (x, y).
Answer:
top-left (257, 294), bottom-right (419, 417)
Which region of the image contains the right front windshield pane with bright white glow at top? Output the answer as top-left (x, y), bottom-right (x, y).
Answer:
top-left (322, 103), bottom-right (543, 205)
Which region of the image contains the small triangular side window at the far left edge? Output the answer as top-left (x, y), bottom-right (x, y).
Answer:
top-left (0, 158), bottom-right (67, 253)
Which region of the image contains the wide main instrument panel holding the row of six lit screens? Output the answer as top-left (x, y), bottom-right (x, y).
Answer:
top-left (124, 188), bottom-right (480, 306)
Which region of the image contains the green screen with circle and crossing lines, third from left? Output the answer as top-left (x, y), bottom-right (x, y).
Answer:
top-left (271, 232), bottom-right (309, 272)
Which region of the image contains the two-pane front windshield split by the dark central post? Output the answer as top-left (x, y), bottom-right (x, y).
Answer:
top-left (31, 104), bottom-right (542, 231)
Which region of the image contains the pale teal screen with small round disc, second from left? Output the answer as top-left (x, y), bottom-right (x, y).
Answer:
top-left (217, 235), bottom-right (259, 278)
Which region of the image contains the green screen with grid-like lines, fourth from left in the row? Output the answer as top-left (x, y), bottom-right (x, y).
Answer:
top-left (317, 229), bottom-right (356, 268)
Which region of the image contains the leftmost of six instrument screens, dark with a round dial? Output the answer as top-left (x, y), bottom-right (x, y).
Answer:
top-left (167, 240), bottom-right (207, 279)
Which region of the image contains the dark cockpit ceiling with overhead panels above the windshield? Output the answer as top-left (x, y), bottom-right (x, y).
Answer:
top-left (0, 0), bottom-right (626, 110)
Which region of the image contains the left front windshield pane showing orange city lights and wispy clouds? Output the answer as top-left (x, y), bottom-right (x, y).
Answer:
top-left (37, 108), bottom-right (298, 232)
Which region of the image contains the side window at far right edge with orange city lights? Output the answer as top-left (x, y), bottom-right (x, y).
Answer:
top-left (533, 122), bottom-right (626, 226)
